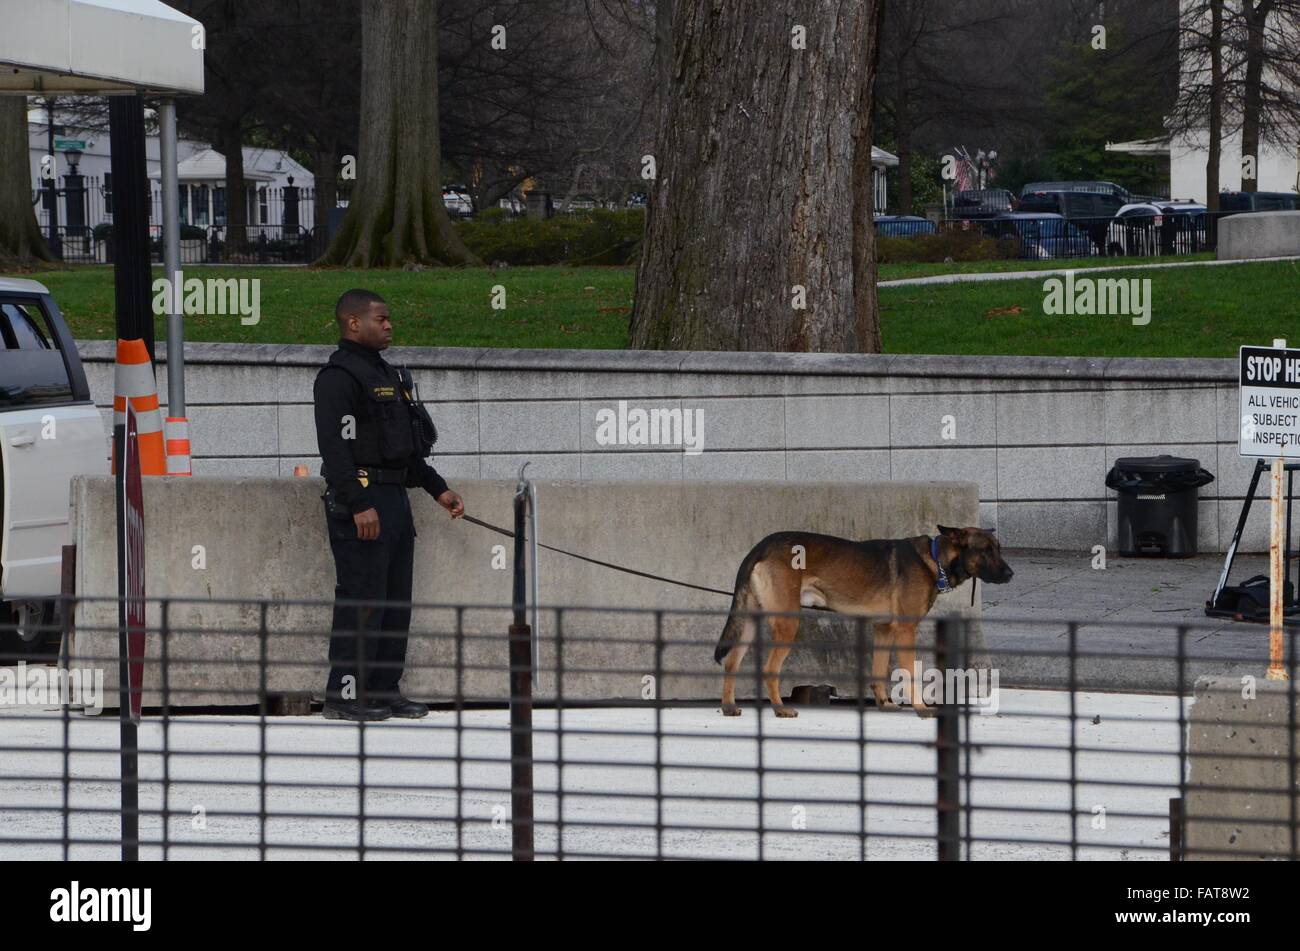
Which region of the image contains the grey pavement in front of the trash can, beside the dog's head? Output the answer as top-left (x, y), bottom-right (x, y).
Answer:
top-left (982, 551), bottom-right (1284, 691)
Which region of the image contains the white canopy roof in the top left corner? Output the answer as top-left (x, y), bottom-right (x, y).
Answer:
top-left (0, 0), bottom-right (204, 96)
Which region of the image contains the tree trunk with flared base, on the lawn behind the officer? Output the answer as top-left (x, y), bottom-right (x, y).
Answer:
top-left (320, 0), bottom-right (480, 268)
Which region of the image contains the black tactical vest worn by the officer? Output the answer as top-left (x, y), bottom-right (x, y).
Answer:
top-left (319, 349), bottom-right (438, 466)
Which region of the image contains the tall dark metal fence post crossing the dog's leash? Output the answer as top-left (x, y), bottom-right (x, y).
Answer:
top-left (510, 479), bottom-right (533, 861)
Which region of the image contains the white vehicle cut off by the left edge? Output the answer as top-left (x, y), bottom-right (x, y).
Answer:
top-left (0, 278), bottom-right (109, 664)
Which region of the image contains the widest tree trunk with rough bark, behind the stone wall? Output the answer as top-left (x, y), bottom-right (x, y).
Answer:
top-left (632, 0), bottom-right (879, 352)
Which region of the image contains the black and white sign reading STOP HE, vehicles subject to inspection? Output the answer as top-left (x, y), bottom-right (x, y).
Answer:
top-left (1238, 347), bottom-right (1300, 459)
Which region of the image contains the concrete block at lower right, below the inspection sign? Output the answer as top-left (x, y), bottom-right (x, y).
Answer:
top-left (1183, 677), bottom-right (1300, 861)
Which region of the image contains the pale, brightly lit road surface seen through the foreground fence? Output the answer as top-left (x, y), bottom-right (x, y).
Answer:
top-left (0, 689), bottom-right (1186, 860)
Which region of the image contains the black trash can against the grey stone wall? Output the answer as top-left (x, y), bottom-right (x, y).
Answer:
top-left (1106, 456), bottom-right (1214, 559)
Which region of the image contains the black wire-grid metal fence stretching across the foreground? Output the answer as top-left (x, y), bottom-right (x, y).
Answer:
top-left (0, 599), bottom-right (1297, 860)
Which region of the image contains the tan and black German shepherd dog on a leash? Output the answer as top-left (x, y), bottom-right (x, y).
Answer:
top-left (714, 525), bottom-right (1013, 717)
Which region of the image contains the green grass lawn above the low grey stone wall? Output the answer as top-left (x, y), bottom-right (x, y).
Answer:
top-left (12, 255), bottom-right (1300, 356)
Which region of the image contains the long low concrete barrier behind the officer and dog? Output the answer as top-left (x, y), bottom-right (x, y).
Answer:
top-left (70, 477), bottom-right (983, 705)
